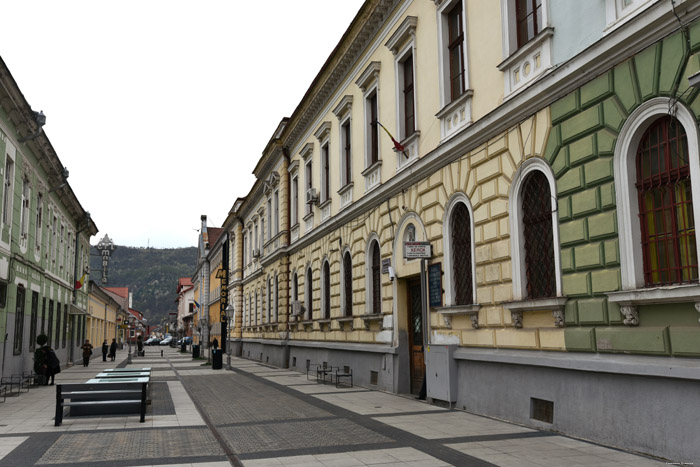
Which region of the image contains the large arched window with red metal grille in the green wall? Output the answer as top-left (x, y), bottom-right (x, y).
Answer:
top-left (636, 116), bottom-right (698, 286)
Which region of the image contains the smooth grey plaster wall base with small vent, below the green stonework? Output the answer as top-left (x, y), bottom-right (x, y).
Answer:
top-left (456, 360), bottom-right (700, 463)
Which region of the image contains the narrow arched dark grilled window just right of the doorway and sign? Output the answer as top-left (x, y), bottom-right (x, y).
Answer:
top-left (450, 203), bottom-right (474, 305)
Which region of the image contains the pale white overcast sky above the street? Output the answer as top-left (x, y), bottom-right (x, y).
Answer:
top-left (0, 0), bottom-right (363, 248)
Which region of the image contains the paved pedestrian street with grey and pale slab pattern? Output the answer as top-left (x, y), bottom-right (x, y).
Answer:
top-left (0, 347), bottom-right (666, 467)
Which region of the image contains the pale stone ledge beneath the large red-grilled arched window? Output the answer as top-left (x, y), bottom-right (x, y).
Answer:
top-left (607, 284), bottom-right (700, 326)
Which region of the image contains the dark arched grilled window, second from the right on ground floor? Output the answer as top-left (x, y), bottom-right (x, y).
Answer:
top-left (521, 170), bottom-right (556, 298)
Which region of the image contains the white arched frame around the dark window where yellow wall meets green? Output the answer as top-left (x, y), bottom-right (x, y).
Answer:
top-left (508, 157), bottom-right (562, 301)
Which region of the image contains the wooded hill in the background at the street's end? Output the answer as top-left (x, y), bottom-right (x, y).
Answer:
top-left (90, 246), bottom-right (197, 324)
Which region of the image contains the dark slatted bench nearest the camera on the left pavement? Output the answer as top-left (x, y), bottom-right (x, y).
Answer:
top-left (54, 382), bottom-right (148, 426)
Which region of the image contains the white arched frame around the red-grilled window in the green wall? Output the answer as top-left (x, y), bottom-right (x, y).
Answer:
top-left (613, 97), bottom-right (700, 290)
